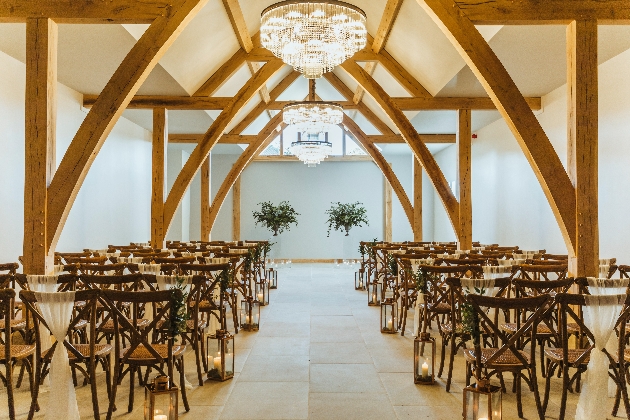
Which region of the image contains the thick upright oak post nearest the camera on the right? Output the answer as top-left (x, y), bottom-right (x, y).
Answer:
top-left (567, 20), bottom-right (599, 276)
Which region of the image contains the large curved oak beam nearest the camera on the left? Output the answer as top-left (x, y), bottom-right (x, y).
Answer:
top-left (47, 0), bottom-right (208, 250)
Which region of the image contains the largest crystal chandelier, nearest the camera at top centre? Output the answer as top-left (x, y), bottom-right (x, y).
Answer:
top-left (260, 0), bottom-right (367, 79)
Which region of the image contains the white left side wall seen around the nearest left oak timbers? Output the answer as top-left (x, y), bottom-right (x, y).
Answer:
top-left (0, 47), bottom-right (151, 262)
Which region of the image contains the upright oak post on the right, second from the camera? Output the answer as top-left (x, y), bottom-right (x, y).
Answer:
top-left (457, 109), bottom-right (472, 250)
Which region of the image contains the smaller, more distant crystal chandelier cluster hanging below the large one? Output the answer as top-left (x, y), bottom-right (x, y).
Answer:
top-left (282, 80), bottom-right (343, 168)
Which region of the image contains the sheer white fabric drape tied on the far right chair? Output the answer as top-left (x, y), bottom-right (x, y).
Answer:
top-left (575, 294), bottom-right (626, 420)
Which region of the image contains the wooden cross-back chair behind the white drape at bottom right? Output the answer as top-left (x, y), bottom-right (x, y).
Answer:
top-left (542, 293), bottom-right (630, 420)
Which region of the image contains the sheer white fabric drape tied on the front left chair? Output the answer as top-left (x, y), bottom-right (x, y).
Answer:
top-left (35, 292), bottom-right (80, 420)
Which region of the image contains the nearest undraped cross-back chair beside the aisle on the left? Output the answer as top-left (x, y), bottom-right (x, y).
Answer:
top-left (101, 289), bottom-right (190, 420)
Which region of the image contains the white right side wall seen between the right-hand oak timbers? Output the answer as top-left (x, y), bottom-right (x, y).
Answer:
top-left (435, 46), bottom-right (630, 264)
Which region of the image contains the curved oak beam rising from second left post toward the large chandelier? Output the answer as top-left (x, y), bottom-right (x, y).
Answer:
top-left (164, 59), bottom-right (283, 232)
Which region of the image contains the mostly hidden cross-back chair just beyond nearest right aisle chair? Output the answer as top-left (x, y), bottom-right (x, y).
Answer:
top-left (437, 277), bottom-right (511, 392)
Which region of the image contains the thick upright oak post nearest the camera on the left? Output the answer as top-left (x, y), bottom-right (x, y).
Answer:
top-left (23, 18), bottom-right (57, 274)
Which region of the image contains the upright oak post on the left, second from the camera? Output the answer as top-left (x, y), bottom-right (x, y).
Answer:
top-left (151, 108), bottom-right (168, 249)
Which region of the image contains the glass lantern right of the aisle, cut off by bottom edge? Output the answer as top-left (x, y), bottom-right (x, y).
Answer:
top-left (464, 379), bottom-right (502, 420)
